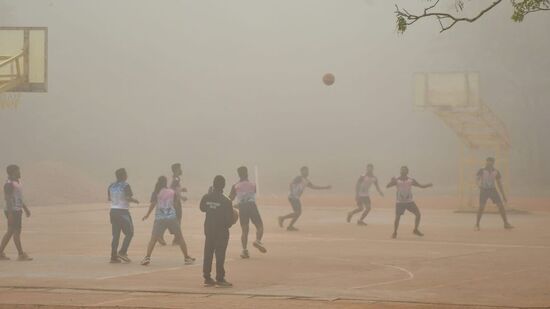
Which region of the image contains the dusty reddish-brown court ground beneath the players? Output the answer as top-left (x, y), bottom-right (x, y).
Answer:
top-left (0, 204), bottom-right (550, 308)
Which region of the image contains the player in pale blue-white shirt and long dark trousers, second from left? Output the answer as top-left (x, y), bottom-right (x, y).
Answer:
top-left (107, 168), bottom-right (139, 263)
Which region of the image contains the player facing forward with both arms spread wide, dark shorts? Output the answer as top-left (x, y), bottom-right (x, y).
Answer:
top-left (386, 166), bottom-right (433, 238)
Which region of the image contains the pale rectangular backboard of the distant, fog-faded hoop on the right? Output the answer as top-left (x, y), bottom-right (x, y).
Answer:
top-left (414, 72), bottom-right (480, 108)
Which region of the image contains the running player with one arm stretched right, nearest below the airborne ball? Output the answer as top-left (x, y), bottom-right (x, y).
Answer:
top-left (279, 166), bottom-right (332, 231)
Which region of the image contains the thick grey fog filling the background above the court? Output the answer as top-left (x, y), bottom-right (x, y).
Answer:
top-left (0, 0), bottom-right (550, 199)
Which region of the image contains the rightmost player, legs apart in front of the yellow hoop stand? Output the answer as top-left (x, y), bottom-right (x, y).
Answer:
top-left (476, 158), bottom-right (514, 231)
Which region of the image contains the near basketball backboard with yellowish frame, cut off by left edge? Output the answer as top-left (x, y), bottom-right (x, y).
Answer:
top-left (0, 27), bottom-right (48, 93)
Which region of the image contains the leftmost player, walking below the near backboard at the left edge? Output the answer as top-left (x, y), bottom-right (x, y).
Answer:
top-left (0, 165), bottom-right (32, 261)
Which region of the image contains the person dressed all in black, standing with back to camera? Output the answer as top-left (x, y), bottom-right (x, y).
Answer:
top-left (200, 175), bottom-right (235, 288)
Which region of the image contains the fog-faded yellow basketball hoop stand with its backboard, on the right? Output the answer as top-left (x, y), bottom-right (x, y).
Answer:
top-left (415, 72), bottom-right (511, 211)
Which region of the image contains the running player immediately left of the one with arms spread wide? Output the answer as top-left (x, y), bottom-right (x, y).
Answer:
top-left (347, 163), bottom-right (384, 225)
